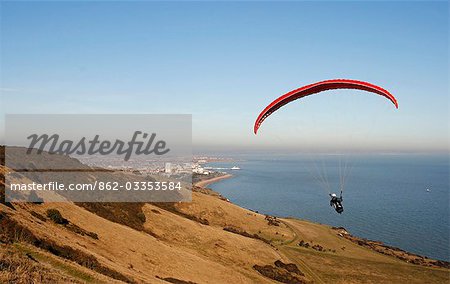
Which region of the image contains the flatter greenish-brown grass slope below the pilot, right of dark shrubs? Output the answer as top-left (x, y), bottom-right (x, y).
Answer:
top-left (278, 219), bottom-right (450, 283)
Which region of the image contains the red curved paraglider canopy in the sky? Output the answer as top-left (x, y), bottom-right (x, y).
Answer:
top-left (253, 79), bottom-right (398, 134)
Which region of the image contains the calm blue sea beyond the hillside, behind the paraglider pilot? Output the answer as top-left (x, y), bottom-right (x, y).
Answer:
top-left (207, 154), bottom-right (450, 261)
